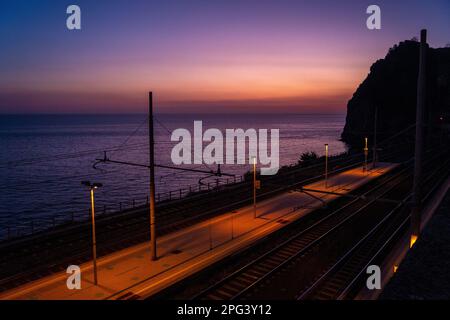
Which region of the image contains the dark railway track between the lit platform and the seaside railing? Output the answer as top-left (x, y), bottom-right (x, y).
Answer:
top-left (0, 152), bottom-right (364, 292)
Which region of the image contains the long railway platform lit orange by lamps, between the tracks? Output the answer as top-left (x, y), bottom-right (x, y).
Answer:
top-left (0, 163), bottom-right (397, 300)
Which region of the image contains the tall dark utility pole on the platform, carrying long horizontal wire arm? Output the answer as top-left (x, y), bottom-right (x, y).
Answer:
top-left (148, 91), bottom-right (158, 261)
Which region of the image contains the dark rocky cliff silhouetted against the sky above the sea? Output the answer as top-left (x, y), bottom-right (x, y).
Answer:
top-left (342, 40), bottom-right (450, 147)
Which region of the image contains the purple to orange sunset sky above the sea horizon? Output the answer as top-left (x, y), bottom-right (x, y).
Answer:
top-left (0, 0), bottom-right (450, 113)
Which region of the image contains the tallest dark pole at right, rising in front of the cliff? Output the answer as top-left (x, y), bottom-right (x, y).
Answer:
top-left (410, 29), bottom-right (428, 247)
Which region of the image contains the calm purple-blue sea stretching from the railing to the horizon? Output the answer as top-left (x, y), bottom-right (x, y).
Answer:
top-left (0, 114), bottom-right (346, 237)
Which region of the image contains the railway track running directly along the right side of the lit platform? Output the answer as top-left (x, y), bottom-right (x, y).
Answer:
top-left (194, 150), bottom-right (450, 300)
